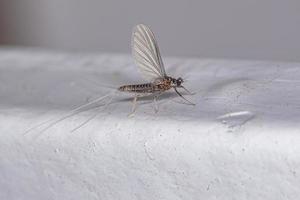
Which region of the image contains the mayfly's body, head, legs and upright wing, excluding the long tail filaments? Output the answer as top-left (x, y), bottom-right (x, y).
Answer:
top-left (118, 24), bottom-right (195, 113)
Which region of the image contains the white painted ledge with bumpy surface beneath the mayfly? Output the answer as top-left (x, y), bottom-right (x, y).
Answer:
top-left (0, 49), bottom-right (300, 200)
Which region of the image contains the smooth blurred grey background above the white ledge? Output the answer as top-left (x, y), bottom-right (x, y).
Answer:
top-left (0, 0), bottom-right (300, 61)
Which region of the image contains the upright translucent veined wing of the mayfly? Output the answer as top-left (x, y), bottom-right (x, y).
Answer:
top-left (132, 24), bottom-right (166, 81)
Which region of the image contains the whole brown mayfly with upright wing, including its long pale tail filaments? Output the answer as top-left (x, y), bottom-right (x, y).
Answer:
top-left (25, 24), bottom-right (195, 134)
